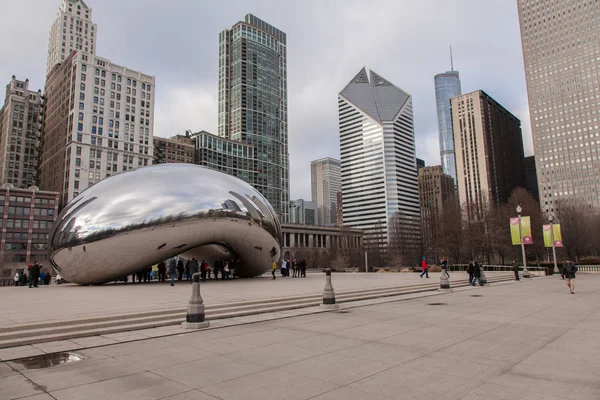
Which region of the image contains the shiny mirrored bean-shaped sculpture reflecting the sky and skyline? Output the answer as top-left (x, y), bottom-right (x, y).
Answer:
top-left (50, 164), bottom-right (281, 285)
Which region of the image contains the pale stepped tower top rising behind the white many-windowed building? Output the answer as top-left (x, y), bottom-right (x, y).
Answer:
top-left (46, 0), bottom-right (98, 75)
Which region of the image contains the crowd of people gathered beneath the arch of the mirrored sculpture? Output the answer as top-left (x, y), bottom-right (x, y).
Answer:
top-left (121, 257), bottom-right (233, 286)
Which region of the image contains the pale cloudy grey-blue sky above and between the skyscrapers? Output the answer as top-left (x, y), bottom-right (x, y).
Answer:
top-left (0, 0), bottom-right (533, 199)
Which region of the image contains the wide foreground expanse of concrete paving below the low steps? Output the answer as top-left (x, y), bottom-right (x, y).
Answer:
top-left (0, 274), bottom-right (600, 400)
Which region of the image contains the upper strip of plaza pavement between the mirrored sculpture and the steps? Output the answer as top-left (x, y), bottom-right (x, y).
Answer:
top-left (0, 272), bottom-right (506, 329)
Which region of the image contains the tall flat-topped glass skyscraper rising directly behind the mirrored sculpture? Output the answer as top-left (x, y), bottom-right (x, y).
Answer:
top-left (218, 14), bottom-right (290, 221)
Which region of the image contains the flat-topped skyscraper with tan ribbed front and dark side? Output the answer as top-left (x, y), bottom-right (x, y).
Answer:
top-left (451, 90), bottom-right (525, 220)
